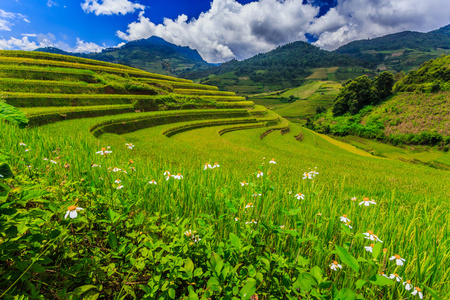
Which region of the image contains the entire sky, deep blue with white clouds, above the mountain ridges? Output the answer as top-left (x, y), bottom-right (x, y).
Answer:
top-left (0, 0), bottom-right (450, 62)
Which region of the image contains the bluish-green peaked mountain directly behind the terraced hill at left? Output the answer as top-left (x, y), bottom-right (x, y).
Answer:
top-left (35, 36), bottom-right (210, 76)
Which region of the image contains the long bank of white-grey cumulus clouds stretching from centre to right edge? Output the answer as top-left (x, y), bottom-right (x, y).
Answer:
top-left (116, 0), bottom-right (450, 62)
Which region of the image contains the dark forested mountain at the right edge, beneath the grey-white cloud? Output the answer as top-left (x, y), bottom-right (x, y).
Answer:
top-left (335, 25), bottom-right (450, 72)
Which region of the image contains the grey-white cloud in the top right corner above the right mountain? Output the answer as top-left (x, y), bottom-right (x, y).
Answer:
top-left (310, 0), bottom-right (450, 50)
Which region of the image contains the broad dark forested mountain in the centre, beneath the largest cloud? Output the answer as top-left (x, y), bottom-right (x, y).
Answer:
top-left (181, 41), bottom-right (375, 93)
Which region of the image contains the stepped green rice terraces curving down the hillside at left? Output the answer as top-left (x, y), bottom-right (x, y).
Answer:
top-left (0, 51), bottom-right (288, 135)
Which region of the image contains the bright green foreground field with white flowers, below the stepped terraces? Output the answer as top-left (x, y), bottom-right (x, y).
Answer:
top-left (1, 117), bottom-right (450, 299)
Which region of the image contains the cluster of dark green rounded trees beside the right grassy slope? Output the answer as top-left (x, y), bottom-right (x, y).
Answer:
top-left (332, 72), bottom-right (394, 116)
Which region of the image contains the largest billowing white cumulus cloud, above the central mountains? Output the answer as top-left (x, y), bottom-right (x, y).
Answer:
top-left (117, 0), bottom-right (318, 63)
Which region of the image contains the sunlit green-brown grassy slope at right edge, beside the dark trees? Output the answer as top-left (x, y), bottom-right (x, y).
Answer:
top-left (310, 55), bottom-right (450, 151)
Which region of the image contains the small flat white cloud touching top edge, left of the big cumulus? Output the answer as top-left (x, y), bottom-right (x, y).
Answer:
top-left (81, 0), bottom-right (145, 16)
